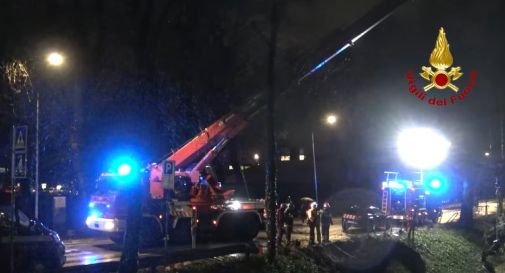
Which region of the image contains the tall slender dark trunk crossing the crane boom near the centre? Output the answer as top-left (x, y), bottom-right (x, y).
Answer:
top-left (265, 0), bottom-right (278, 263)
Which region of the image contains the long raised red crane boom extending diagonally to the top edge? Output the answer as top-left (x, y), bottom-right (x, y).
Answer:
top-left (150, 0), bottom-right (406, 198)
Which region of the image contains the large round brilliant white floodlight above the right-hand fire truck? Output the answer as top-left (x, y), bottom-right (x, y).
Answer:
top-left (397, 128), bottom-right (451, 170)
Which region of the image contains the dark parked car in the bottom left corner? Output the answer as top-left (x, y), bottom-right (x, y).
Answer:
top-left (0, 206), bottom-right (66, 272)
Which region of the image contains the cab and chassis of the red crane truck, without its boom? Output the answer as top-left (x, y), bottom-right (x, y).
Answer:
top-left (86, 165), bottom-right (264, 246)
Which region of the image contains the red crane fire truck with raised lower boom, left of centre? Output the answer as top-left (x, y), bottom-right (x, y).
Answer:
top-left (86, 97), bottom-right (264, 245)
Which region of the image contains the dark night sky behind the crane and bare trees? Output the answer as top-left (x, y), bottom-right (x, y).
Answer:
top-left (0, 0), bottom-right (505, 200)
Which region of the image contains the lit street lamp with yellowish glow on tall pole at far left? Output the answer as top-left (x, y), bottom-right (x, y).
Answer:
top-left (35, 52), bottom-right (65, 219)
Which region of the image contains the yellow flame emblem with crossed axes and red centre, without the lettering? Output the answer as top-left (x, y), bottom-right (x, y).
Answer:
top-left (419, 27), bottom-right (463, 92)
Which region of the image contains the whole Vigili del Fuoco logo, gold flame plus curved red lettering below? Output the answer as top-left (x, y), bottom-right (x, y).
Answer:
top-left (407, 28), bottom-right (477, 106)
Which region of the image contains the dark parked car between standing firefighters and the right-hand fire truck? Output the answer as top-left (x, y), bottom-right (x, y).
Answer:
top-left (342, 205), bottom-right (389, 232)
